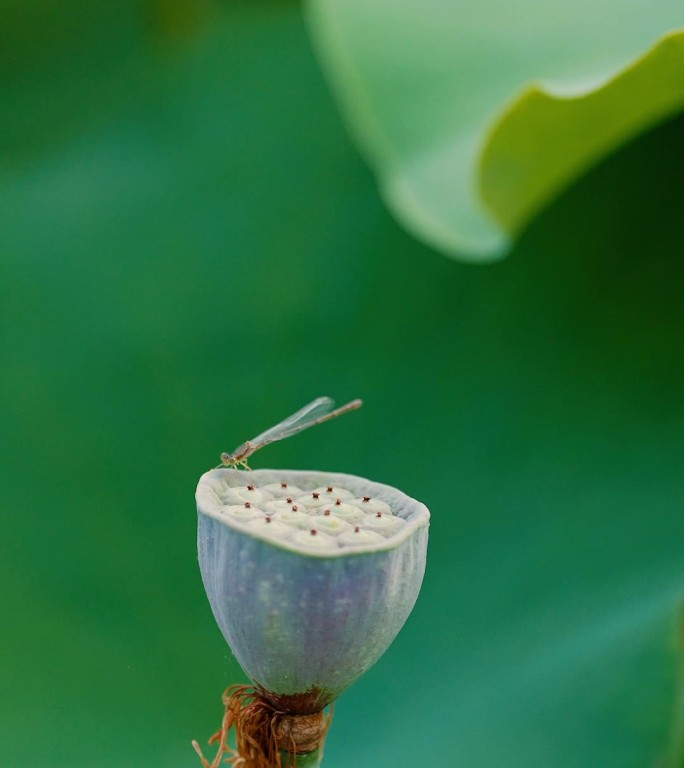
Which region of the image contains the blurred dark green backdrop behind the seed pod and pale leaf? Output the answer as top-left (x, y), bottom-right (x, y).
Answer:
top-left (0, 0), bottom-right (684, 768)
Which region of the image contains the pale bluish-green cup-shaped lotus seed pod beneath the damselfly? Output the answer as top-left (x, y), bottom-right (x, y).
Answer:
top-left (196, 468), bottom-right (430, 715)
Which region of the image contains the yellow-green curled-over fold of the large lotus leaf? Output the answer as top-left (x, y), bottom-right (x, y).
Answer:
top-left (478, 30), bottom-right (684, 237)
